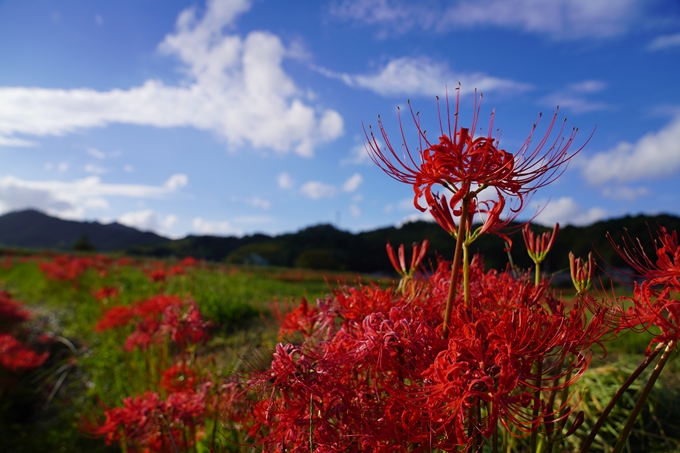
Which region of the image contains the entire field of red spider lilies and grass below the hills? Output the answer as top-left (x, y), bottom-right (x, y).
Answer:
top-left (0, 89), bottom-right (680, 453)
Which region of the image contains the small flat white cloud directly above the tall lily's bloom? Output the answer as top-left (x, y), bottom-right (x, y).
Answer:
top-left (316, 57), bottom-right (530, 96)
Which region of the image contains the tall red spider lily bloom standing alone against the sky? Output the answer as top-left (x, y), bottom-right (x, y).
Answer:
top-left (366, 88), bottom-right (580, 240)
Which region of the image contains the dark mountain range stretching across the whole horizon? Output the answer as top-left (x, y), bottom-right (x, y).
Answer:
top-left (0, 210), bottom-right (680, 272)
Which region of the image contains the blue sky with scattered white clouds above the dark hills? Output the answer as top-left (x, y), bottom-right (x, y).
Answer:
top-left (0, 0), bottom-right (680, 237)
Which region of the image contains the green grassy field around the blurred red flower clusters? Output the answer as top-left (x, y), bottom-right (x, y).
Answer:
top-left (0, 255), bottom-right (680, 453)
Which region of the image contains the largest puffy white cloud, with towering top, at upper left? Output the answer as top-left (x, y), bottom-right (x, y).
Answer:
top-left (0, 0), bottom-right (343, 156)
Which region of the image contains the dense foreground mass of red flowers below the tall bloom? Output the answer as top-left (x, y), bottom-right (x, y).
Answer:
top-left (243, 251), bottom-right (611, 452)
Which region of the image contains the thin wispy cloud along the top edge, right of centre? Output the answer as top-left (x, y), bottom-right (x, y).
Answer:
top-left (331, 0), bottom-right (645, 40)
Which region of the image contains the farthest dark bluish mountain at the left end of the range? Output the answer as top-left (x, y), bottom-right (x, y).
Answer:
top-left (0, 209), bottom-right (169, 252)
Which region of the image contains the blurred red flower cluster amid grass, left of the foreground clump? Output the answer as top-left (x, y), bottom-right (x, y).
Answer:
top-left (95, 295), bottom-right (210, 351)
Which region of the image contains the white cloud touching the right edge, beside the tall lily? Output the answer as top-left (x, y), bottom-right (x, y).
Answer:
top-left (578, 115), bottom-right (680, 184)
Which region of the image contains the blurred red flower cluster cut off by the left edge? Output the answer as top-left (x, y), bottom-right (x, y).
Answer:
top-left (0, 291), bottom-right (48, 372)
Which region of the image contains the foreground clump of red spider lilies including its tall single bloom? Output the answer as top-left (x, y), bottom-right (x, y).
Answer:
top-left (238, 90), bottom-right (618, 452)
